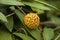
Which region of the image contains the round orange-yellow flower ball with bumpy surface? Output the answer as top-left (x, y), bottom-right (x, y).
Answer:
top-left (24, 13), bottom-right (40, 29)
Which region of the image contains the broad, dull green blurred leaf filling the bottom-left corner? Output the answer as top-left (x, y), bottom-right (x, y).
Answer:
top-left (0, 28), bottom-right (13, 40)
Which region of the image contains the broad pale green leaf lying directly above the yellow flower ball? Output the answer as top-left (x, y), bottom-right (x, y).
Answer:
top-left (22, 1), bottom-right (50, 10)
